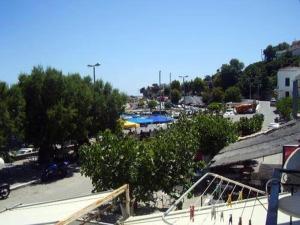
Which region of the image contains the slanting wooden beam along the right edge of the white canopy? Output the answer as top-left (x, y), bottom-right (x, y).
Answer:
top-left (56, 184), bottom-right (129, 225)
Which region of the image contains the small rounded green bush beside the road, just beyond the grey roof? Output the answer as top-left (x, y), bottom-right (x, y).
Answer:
top-left (236, 114), bottom-right (264, 136)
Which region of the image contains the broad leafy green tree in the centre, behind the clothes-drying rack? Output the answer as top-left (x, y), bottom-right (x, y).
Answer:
top-left (80, 115), bottom-right (236, 201)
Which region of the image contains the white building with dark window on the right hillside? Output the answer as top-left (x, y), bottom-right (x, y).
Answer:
top-left (277, 67), bottom-right (300, 99)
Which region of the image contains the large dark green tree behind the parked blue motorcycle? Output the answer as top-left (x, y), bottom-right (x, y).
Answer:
top-left (18, 67), bottom-right (125, 162)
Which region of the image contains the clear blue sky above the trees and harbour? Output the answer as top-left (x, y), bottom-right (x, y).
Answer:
top-left (0, 0), bottom-right (300, 95)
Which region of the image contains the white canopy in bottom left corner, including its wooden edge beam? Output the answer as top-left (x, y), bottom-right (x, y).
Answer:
top-left (0, 185), bottom-right (128, 225)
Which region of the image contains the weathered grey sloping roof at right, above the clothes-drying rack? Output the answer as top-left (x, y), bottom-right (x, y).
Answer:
top-left (210, 121), bottom-right (300, 167)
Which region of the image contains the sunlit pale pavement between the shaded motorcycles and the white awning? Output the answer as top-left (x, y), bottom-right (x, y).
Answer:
top-left (0, 173), bottom-right (93, 211)
